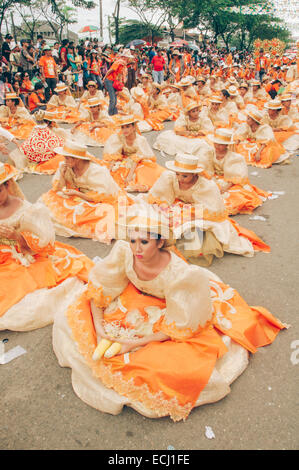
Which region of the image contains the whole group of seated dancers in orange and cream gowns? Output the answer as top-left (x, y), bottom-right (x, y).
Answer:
top-left (0, 70), bottom-right (298, 421)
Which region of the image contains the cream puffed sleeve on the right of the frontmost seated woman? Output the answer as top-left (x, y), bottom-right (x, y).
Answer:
top-left (158, 260), bottom-right (212, 340)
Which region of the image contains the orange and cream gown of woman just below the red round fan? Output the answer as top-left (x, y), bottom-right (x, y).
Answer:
top-left (40, 161), bottom-right (128, 243)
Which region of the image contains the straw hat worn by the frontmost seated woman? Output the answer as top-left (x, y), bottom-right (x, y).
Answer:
top-left (117, 205), bottom-right (171, 244)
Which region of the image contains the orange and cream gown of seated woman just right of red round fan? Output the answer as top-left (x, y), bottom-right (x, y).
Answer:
top-left (100, 133), bottom-right (164, 191)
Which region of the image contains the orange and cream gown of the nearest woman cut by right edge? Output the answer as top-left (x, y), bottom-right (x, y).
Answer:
top-left (262, 112), bottom-right (299, 152)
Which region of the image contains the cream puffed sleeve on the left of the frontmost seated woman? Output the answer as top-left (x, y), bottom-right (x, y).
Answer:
top-left (88, 240), bottom-right (130, 308)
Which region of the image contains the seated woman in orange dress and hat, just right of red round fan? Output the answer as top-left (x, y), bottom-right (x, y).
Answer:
top-left (101, 116), bottom-right (164, 192)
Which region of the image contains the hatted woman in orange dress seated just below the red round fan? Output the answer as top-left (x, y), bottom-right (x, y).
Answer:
top-left (40, 141), bottom-right (131, 244)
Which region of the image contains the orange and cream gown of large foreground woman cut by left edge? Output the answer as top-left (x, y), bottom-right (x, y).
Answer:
top-left (0, 200), bottom-right (93, 331)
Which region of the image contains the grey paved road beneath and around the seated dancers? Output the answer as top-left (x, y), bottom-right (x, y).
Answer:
top-left (0, 123), bottom-right (299, 450)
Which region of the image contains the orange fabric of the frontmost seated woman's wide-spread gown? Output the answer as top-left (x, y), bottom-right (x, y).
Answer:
top-left (67, 282), bottom-right (284, 421)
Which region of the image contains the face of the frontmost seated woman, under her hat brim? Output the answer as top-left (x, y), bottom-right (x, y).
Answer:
top-left (129, 230), bottom-right (163, 263)
